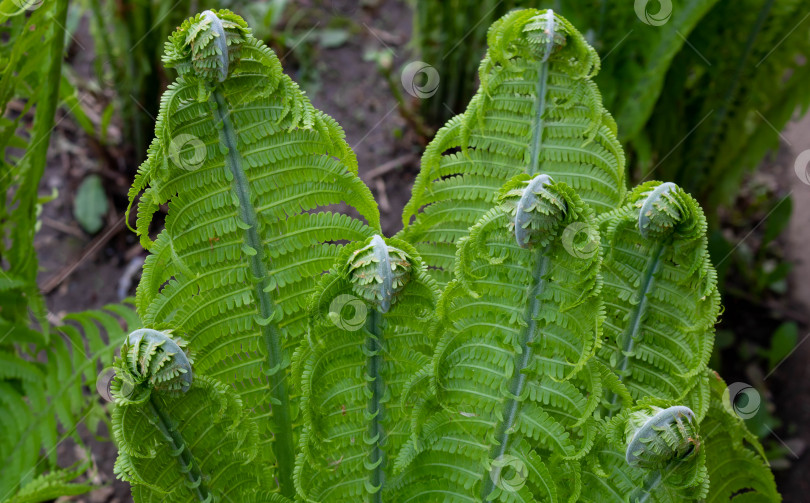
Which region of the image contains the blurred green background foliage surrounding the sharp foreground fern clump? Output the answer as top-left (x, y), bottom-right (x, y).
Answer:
top-left (0, 0), bottom-right (810, 502)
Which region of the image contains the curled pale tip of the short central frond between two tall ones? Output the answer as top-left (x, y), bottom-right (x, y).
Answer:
top-left (348, 235), bottom-right (413, 313)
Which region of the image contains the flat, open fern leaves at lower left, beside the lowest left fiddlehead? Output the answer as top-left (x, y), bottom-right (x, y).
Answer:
top-left (0, 305), bottom-right (139, 501)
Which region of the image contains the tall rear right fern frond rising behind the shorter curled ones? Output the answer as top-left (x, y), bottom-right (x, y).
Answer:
top-left (402, 9), bottom-right (625, 284)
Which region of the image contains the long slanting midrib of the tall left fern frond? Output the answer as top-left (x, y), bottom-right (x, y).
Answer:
top-left (211, 88), bottom-right (295, 498)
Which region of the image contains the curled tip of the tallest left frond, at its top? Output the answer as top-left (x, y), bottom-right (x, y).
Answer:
top-left (163, 9), bottom-right (250, 83)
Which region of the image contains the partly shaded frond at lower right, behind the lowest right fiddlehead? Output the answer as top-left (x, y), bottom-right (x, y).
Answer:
top-left (700, 371), bottom-right (782, 503)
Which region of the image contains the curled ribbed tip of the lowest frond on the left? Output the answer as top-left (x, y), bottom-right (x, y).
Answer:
top-left (110, 328), bottom-right (192, 404)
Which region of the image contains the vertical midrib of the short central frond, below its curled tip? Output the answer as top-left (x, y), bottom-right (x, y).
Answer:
top-left (366, 309), bottom-right (385, 503)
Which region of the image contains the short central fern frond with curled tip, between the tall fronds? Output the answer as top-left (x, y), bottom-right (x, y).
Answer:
top-left (294, 236), bottom-right (437, 503)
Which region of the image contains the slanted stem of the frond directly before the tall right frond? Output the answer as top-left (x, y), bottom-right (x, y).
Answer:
top-left (481, 248), bottom-right (549, 502)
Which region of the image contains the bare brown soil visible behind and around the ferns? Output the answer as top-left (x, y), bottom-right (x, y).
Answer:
top-left (31, 1), bottom-right (810, 502)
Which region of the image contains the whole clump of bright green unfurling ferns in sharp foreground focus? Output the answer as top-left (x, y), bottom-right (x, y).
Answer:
top-left (111, 10), bottom-right (779, 503)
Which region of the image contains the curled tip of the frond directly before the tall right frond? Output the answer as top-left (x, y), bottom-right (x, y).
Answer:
top-left (501, 175), bottom-right (567, 248)
